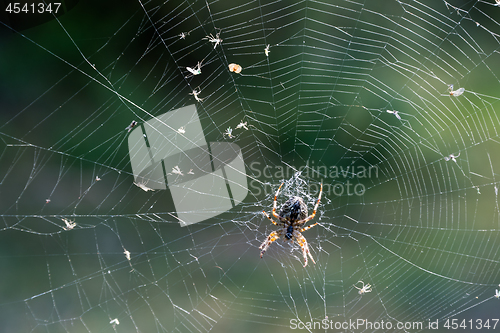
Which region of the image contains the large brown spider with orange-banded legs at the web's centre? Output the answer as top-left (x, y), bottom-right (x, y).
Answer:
top-left (259, 183), bottom-right (323, 267)
